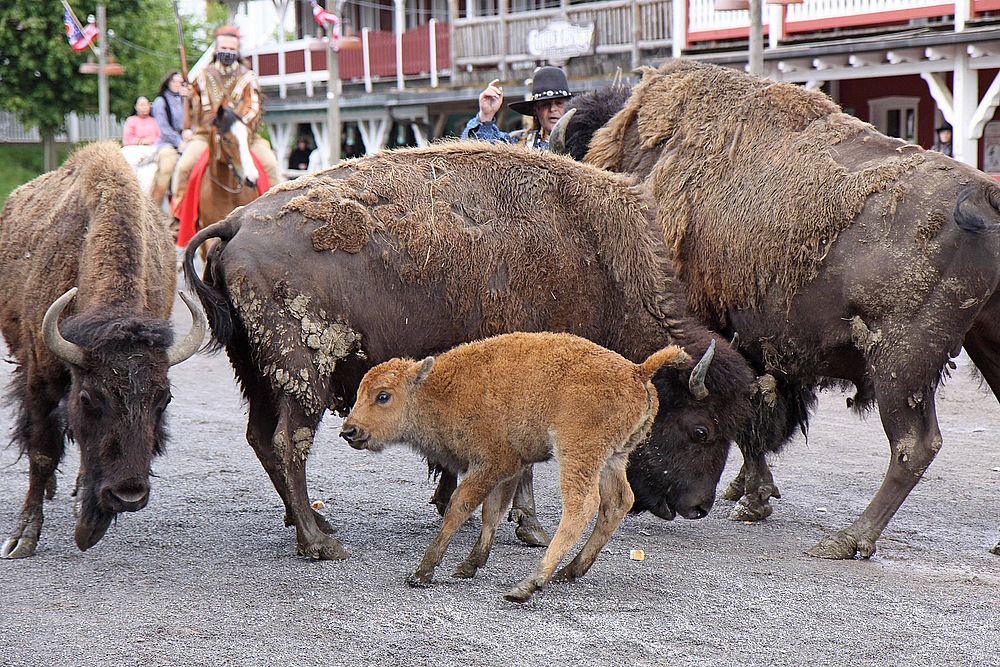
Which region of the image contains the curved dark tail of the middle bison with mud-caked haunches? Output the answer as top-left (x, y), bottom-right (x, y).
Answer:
top-left (183, 216), bottom-right (239, 352)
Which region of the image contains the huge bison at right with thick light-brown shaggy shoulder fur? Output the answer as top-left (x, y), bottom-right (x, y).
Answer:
top-left (556, 60), bottom-right (1000, 558)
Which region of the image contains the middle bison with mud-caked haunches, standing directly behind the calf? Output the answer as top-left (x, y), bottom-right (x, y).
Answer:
top-left (184, 142), bottom-right (753, 558)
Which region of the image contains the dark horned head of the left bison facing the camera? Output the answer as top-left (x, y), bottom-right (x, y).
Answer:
top-left (42, 288), bottom-right (206, 550)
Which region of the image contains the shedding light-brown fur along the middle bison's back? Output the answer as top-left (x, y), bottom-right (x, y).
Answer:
top-left (277, 142), bottom-right (672, 326)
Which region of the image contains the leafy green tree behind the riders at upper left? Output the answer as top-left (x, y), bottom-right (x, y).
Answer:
top-left (0, 0), bottom-right (208, 170)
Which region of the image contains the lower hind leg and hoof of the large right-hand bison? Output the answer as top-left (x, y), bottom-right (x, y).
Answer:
top-left (808, 387), bottom-right (941, 559)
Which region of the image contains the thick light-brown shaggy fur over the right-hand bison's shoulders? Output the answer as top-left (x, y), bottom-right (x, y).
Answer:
top-left (586, 60), bottom-right (928, 324)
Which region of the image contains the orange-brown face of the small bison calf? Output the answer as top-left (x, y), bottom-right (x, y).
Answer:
top-left (340, 357), bottom-right (434, 452)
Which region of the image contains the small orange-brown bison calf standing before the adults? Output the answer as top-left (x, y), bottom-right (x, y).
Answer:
top-left (340, 333), bottom-right (689, 602)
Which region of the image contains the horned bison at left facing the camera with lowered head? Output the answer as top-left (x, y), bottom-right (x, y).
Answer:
top-left (0, 143), bottom-right (207, 558)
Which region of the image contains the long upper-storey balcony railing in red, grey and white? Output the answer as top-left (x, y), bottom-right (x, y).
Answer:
top-left (252, 0), bottom-right (1000, 97)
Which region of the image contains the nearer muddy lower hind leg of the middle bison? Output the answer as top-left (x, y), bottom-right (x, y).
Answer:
top-left (271, 397), bottom-right (348, 560)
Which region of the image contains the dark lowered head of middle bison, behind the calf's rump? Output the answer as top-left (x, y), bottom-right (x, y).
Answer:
top-left (628, 336), bottom-right (754, 520)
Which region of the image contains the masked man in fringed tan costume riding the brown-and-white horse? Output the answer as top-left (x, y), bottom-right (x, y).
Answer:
top-left (172, 26), bottom-right (281, 217)
